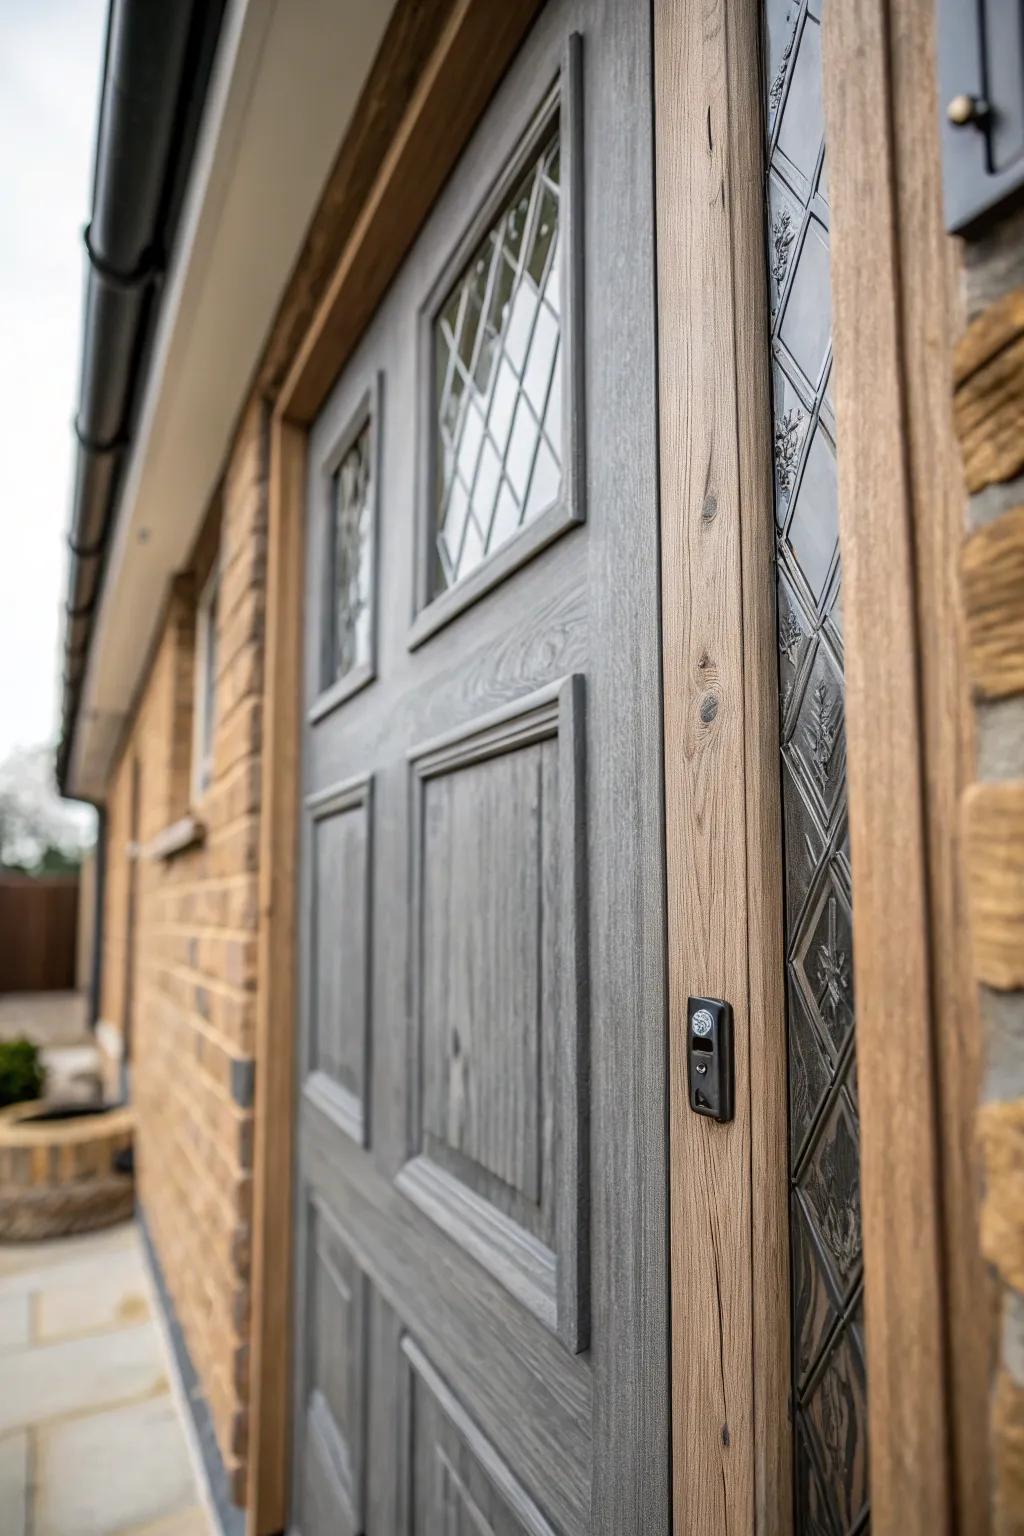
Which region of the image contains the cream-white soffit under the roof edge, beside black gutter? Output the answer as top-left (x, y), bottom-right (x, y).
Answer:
top-left (68, 0), bottom-right (393, 800)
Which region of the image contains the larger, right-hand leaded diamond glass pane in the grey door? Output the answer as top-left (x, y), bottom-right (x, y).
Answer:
top-left (433, 132), bottom-right (562, 593)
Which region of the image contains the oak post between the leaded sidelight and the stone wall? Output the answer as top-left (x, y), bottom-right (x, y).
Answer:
top-left (823, 0), bottom-right (989, 1536)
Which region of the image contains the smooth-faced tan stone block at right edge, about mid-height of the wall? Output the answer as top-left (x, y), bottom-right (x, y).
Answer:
top-left (964, 780), bottom-right (1024, 991)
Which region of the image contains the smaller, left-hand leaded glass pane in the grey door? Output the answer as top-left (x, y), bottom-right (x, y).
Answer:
top-left (324, 421), bottom-right (373, 687)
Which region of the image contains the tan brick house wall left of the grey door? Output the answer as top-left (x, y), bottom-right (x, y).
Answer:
top-left (101, 404), bottom-right (266, 1502)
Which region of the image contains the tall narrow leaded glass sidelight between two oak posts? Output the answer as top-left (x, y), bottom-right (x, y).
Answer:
top-left (763, 0), bottom-right (867, 1536)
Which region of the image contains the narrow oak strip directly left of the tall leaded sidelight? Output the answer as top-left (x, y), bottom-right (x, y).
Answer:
top-left (725, 0), bottom-right (792, 1536)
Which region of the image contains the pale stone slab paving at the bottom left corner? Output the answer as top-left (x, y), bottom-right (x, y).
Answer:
top-left (0, 1223), bottom-right (215, 1536)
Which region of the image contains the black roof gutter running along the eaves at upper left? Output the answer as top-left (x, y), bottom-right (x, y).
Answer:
top-left (57, 0), bottom-right (226, 791)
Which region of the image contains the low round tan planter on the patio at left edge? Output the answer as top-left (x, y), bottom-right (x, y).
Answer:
top-left (0, 1100), bottom-right (134, 1243)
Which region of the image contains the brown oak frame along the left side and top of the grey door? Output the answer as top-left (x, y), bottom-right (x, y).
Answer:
top-left (246, 0), bottom-right (540, 1536)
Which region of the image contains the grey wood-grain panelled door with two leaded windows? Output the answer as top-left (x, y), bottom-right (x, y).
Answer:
top-left (293, 0), bottom-right (669, 1536)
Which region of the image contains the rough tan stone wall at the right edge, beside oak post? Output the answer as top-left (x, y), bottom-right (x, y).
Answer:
top-left (953, 210), bottom-right (1024, 1536)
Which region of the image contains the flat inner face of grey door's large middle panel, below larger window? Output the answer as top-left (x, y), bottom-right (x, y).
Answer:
top-left (421, 743), bottom-right (557, 1198)
